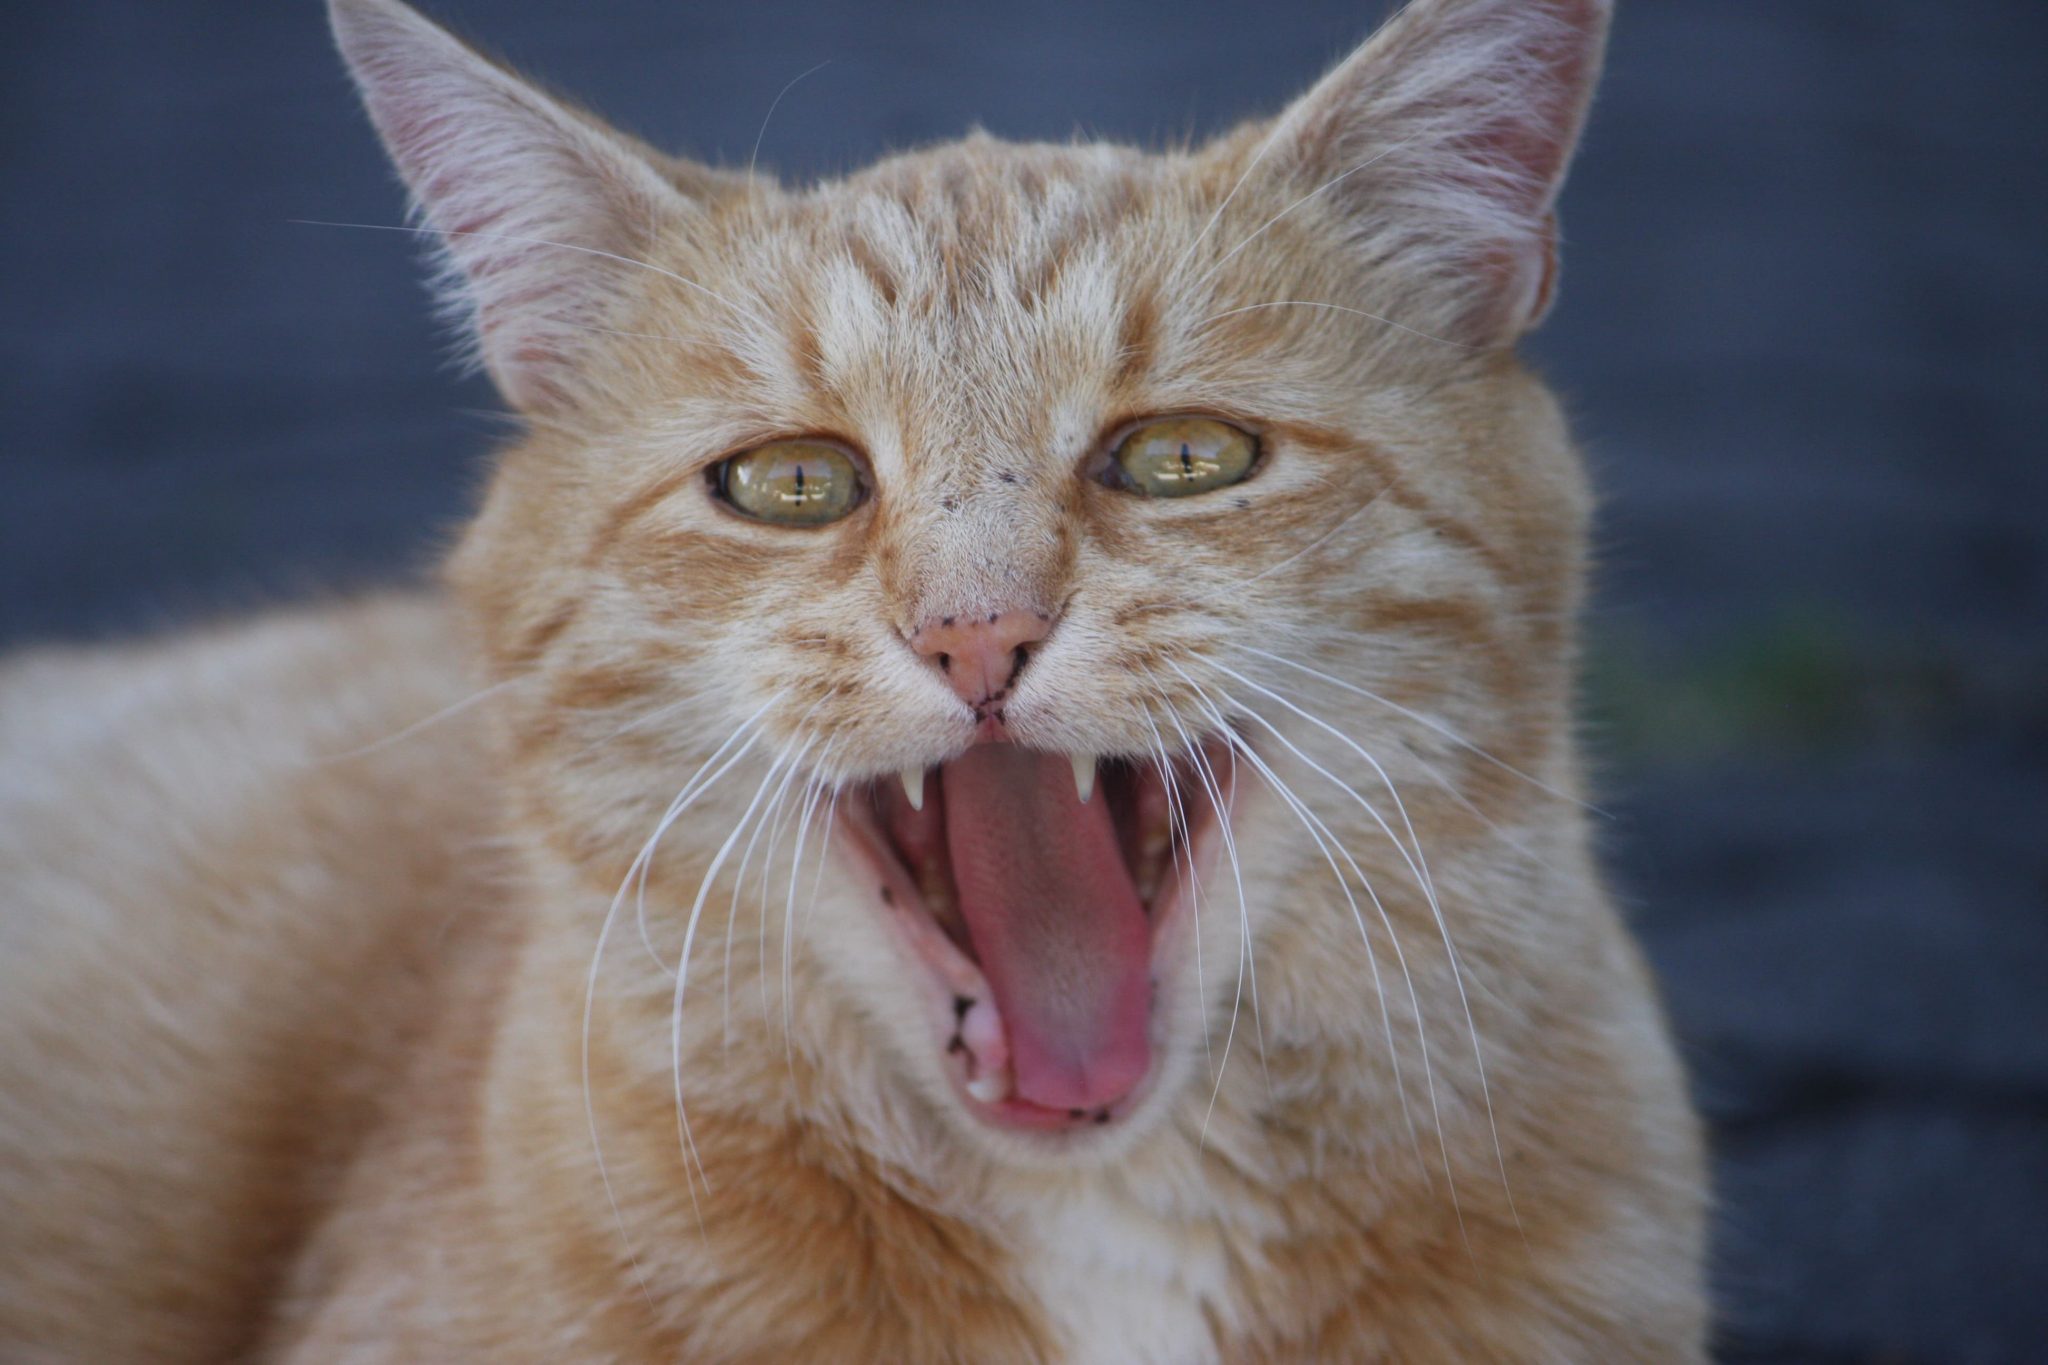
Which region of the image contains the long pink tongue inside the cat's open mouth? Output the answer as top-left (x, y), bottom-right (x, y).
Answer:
top-left (942, 745), bottom-right (1151, 1109)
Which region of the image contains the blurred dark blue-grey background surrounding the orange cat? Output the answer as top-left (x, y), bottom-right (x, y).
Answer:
top-left (0, 0), bottom-right (2048, 1365)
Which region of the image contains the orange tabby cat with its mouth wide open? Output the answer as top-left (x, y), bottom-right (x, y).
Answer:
top-left (0, 0), bottom-right (1708, 1365)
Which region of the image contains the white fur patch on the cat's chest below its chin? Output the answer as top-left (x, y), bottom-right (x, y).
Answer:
top-left (1014, 1185), bottom-right (1231, 1365)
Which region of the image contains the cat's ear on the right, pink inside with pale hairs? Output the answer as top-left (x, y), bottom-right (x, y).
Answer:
top-left (1264, 0), bottom-right (1612, 346)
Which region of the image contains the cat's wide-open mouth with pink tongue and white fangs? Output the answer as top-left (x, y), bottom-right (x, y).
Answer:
top-left (848, 743), bottom-right (1231, 1132)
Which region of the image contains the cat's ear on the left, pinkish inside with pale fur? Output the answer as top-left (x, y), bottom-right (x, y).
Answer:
top-left (330, 0), bottom-right (692, 411)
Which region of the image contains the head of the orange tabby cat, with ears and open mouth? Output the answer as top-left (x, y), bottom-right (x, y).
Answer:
top-left (334, 0), bottom-right (1606, 1152)
